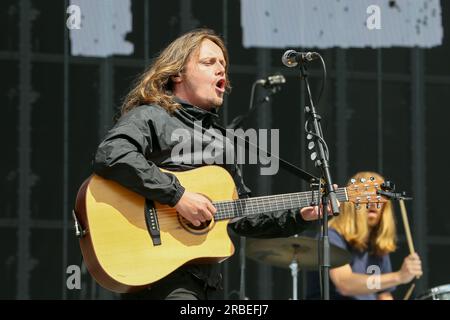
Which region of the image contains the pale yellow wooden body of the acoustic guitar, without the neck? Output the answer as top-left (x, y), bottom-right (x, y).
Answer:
top-left (76, 166), bottom-right (238, 293)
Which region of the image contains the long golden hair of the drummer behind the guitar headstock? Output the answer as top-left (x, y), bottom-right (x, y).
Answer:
top-left (329, 171), bottom-right (397, 256)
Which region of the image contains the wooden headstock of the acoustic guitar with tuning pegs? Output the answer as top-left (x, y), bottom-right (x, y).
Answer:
top-left (346, 177), bottom-right (389, 209)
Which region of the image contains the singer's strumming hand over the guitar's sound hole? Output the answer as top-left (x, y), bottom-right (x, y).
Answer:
top-left (175, 191), bottom-right (217, 227)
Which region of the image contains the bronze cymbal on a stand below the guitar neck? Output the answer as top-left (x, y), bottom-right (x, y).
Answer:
top-left (246, 237), bottom-right (351, 269)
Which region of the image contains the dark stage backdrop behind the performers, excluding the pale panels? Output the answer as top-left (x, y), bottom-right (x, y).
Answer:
top-left (0, 0), bottom-right (450, 299)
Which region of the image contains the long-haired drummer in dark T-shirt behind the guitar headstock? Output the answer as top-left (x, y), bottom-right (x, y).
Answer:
top-left (307, 172), bottom-right (422, 300)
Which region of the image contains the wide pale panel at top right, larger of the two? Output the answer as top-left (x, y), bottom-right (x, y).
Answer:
top-left (241, 0), bottom-right (443, 48)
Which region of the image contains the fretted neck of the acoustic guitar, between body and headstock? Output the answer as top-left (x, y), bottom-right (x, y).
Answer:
top-left (213, 188), bottom-right (348, 220)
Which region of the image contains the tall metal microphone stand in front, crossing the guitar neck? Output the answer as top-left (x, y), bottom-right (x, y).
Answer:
top-left (299, 60), bottom-right (339, 300)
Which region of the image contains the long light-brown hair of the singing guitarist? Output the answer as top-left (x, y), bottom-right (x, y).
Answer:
top-left (121, 29), bottom-right (230, 114)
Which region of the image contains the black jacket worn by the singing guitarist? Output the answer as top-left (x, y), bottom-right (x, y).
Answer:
top-left (93, 101), bottom-right (309, 287)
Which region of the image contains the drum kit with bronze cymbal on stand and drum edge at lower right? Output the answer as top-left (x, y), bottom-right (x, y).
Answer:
top-left (246, 236), bottom-right (450, 300)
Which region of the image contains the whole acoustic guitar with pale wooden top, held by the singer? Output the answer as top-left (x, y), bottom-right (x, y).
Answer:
top-left (74, 166), bottom-right (387, 293)
